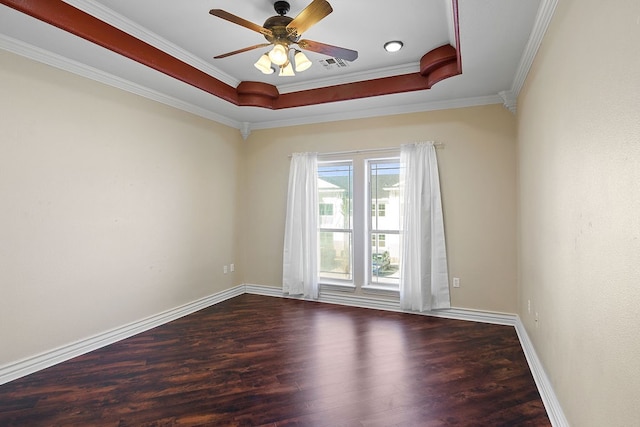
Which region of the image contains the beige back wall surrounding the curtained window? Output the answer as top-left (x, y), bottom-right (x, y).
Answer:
top-left (242, 105), bottom-right (517, 313)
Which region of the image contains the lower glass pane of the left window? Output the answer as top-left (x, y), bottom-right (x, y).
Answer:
top-left (320, 231), bottom-right (352, 280)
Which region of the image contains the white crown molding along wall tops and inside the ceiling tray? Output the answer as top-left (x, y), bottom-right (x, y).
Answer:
top-left (0, 0), bottom-right (557, 131)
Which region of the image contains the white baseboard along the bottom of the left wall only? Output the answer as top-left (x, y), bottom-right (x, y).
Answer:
top-left (0, 285), bottom-right (245, 385)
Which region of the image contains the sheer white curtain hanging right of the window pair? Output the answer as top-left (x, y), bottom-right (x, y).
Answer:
top-left (400, 142), bottom-right (451, 311)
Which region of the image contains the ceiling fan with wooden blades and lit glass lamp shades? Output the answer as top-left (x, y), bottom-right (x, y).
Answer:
top-left (209, 0), bottom-right (358, 76)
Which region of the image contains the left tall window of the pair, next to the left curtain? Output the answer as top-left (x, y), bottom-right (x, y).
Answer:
top-left (318, 162), bottom-right (353, 282)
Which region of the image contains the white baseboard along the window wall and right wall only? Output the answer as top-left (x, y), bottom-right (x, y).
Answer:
top-left (245, 284), bottom-right (569, 427)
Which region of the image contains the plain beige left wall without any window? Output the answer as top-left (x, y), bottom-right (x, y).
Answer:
top-left (0, 51), bottom-right (242, 366)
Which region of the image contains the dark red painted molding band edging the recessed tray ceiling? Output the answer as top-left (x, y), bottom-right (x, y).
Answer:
top-left (0, 0), bottom-right (462, 110)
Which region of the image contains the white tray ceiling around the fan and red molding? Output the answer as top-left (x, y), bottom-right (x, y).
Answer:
top-left (0, 0), bottom-right (555, 136)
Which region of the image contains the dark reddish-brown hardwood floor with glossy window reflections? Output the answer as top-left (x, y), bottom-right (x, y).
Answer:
top-left (0, 294), bottom-right (550, 427)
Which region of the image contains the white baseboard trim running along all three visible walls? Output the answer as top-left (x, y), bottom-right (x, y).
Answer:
top-left (0, 284), bottom-right (569, 427)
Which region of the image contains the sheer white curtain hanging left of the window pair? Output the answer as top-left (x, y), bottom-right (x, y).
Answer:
top-left (282, 153), bottom-right (318, 299)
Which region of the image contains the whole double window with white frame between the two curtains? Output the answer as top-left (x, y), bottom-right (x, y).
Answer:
top-left (318, 155), bottom-right (400, 291)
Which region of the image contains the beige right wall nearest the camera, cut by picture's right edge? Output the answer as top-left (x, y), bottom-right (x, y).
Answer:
top-left (518, 0), bottom-right (640, 426)
